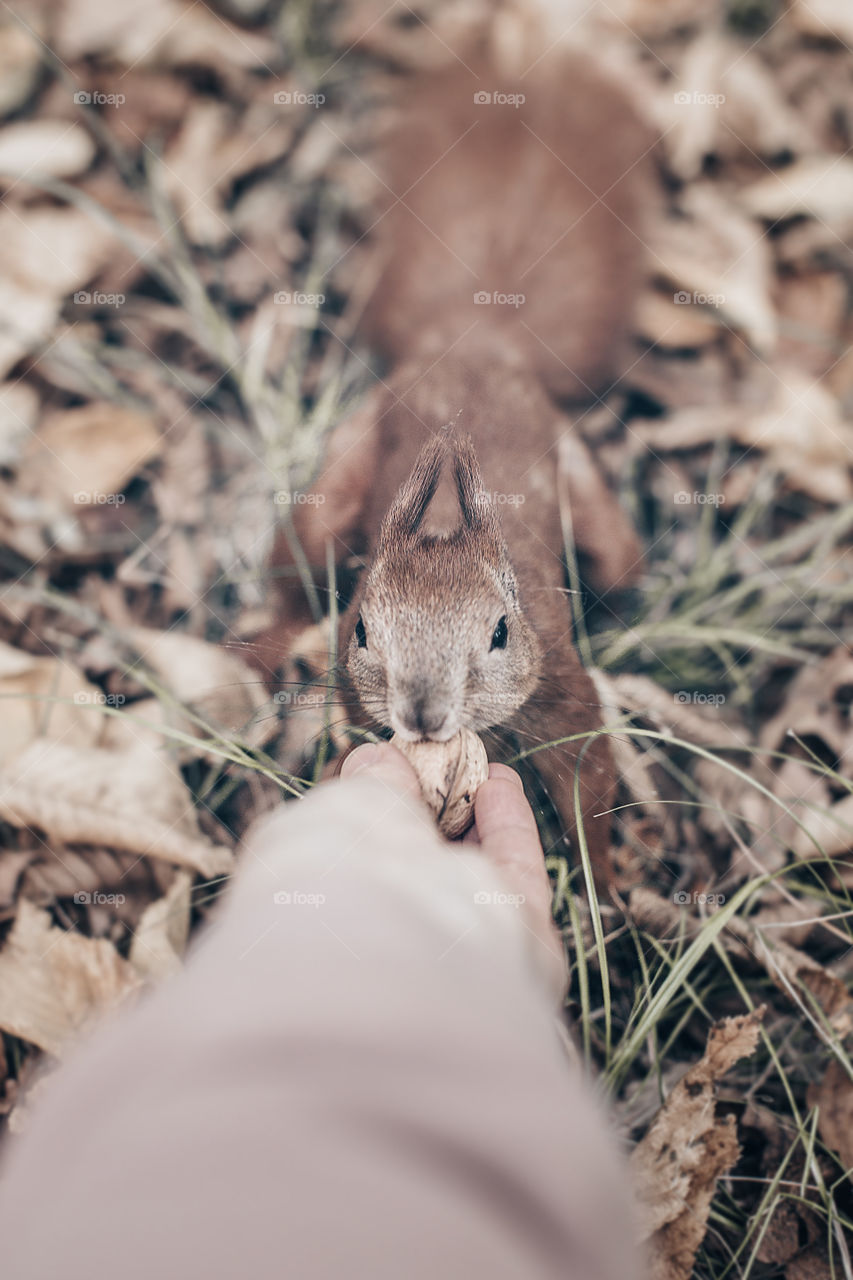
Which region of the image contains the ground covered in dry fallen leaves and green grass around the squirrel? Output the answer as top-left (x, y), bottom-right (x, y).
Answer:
top-left (0, 0), bottom-right (853, 1280)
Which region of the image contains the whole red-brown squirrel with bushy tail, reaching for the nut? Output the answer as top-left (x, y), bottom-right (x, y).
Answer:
top-left (257, 37), bottom-right (654, 886)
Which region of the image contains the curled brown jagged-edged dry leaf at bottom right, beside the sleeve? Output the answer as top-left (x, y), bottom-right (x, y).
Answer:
top-left (631, 1010), bottom-right (763, 1280)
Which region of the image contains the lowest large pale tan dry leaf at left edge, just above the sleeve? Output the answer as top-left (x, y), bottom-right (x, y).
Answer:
top-left (0, 901), bottom-right (140, 1055)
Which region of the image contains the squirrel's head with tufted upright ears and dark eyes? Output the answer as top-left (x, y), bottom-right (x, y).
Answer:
top-left (346, 433), bottom-right (540, 741)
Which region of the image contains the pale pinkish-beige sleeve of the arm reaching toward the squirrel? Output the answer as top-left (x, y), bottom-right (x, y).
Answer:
top-left (0, 777), bottom-right (639, 1280)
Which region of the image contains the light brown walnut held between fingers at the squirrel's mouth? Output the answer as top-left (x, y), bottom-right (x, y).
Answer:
top-left (392, 728), bottom-right (489, 840)
